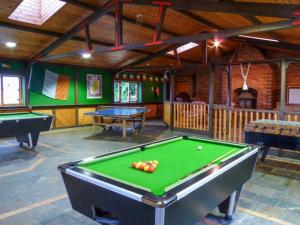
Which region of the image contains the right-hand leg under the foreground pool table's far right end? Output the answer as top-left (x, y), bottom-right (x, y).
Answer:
top-left (219, 189), bottom-right (241, 220)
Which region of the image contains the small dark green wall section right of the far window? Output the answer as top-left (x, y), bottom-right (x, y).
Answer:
top-left (142, 80), bottom-right (163, 103)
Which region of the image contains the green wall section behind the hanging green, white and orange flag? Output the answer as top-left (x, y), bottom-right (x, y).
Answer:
top-left (29, 63), bottom-right (75, 106)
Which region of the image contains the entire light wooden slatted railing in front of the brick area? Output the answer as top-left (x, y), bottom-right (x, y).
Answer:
top-left (164, 102), bottom-right (300, 143)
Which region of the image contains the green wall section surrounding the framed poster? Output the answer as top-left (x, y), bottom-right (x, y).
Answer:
top-left (78, 68), bottom-right (113, 104)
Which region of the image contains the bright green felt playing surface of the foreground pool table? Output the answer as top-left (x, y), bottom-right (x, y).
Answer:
top-left (77, 137), bottom-right (247, 196)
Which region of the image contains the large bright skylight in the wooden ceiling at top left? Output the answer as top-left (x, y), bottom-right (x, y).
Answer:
top-left (8, 0), bottom-right (66, 25)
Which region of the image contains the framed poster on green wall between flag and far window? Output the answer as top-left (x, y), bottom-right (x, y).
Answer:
top-left (86, 74), bottom-right (102, 99)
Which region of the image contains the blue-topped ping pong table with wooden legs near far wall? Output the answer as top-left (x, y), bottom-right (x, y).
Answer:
top-left (85, 106), bottom-right (149, 138)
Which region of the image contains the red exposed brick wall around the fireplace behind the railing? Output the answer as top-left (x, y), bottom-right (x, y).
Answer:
top-left (176, 45), bottom-right (300, 109)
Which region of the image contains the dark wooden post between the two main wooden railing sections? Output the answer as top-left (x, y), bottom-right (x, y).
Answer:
top-left (208, 63), bottom-right (215, 138)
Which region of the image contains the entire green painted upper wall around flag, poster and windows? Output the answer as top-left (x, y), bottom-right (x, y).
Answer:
top-left (0, 60), bottom-right (163, 106)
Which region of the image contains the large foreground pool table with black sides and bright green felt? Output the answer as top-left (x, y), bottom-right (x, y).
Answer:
top-left (58, 136), bottom-right (258, 225)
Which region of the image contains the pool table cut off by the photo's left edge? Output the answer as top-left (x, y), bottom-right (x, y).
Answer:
top-left (0, 112), bottom-right (52, 150)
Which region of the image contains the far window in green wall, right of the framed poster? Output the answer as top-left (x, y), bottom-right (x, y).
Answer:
top-left (114, 81), bottom-right (140, 103)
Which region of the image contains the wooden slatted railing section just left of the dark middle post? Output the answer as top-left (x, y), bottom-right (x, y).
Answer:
top-left (173, 102), bottom-right (208, 131)
